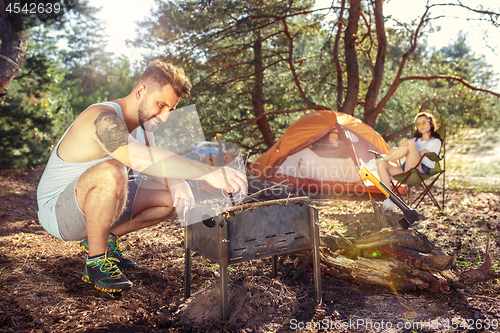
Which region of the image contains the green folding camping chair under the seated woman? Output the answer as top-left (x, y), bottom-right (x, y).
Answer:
top-left (392, 125), bottom-right (446, 210)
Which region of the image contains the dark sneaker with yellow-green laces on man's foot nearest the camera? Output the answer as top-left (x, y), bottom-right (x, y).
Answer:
top-left (82, 253), bottom-right (133, 293)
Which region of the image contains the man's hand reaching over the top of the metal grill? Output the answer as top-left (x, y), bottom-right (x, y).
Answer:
top-left (200, 167), bottom-right (248, 195)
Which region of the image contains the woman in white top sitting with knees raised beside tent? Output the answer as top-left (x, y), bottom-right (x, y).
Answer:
top-left (376, 112), bottom-right (441, 209)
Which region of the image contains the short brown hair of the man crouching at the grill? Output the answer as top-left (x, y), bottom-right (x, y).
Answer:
top-left (137, 61), bottom-right (192, 98)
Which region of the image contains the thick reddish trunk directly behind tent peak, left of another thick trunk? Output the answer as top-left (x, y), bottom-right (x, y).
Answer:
top-left (342, 0), bottom-right (361, 115)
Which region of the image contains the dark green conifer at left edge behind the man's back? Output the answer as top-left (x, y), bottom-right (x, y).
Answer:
top-left (0, 34), bottom-right (73, 169)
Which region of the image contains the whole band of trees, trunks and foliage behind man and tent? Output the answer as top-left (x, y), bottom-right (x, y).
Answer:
top-left (0, 0), bottom-right (500, 169)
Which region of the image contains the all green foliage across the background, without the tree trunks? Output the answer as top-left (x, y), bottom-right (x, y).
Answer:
top-left (0, 0), bottom-right (500, 168)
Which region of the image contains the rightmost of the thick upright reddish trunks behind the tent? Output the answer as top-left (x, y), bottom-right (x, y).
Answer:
top-left (363, 0), bottom-right (387, 127)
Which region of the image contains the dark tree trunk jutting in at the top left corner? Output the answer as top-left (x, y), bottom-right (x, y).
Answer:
top-left (0, 1), bottom-right (28, 92)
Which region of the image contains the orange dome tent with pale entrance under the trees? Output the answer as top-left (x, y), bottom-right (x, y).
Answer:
top-left (250, 111), bottom-right (389, 195)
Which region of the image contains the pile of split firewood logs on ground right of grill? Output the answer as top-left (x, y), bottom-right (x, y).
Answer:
top-left (322, 228), bottom-right (453, 292)
